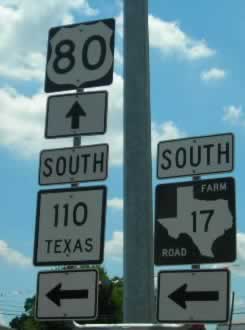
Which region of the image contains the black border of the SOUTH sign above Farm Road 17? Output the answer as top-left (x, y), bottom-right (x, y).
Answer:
top-left (156, 132), bottom-right (235, 180)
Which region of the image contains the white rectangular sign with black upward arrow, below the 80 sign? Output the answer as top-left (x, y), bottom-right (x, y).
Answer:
top-left (45, 91), bottom-right (108, 139)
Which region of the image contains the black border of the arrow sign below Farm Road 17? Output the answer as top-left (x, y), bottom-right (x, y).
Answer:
top-left (157, 269), bottom-right (230, 323)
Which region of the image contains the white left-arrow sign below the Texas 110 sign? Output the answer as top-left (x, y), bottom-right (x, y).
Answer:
top-left (35, 270), bottom-right (98, 320)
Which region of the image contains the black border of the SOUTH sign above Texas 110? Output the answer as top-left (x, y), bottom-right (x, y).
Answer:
top-left (38, 143), bottom-right (109, 186)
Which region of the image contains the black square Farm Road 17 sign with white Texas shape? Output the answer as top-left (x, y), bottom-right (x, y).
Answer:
top-left (155, 178), bottom-right (236, 265)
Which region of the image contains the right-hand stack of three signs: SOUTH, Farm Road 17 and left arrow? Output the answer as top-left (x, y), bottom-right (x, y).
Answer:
top-left (154, 133), bottom-right (236, 323)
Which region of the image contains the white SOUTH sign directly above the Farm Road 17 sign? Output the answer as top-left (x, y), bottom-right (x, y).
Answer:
top-left (157, 133), bottom-right (234, 179)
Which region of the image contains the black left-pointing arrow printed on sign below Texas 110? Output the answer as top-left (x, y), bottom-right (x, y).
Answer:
top-left (46, 283), bottom-right (88, 306)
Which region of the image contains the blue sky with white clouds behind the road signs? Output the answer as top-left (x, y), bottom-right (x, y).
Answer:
top-left (0, 0), bottom-right (245, 323)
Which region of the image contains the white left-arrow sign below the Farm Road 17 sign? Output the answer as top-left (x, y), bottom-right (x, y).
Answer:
top-left (157, 269), bottom-right (230, 323)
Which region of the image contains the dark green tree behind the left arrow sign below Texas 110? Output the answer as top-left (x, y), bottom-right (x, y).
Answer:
top-left (9, 266), bottom-right (123, 330)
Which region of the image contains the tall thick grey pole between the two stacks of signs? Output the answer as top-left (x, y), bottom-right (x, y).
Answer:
top-left (124, 0), bottom-right (155, 323)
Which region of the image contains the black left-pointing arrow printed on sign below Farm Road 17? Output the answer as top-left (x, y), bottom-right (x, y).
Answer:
top-left (168, 284), bottom-right (219, 309)
